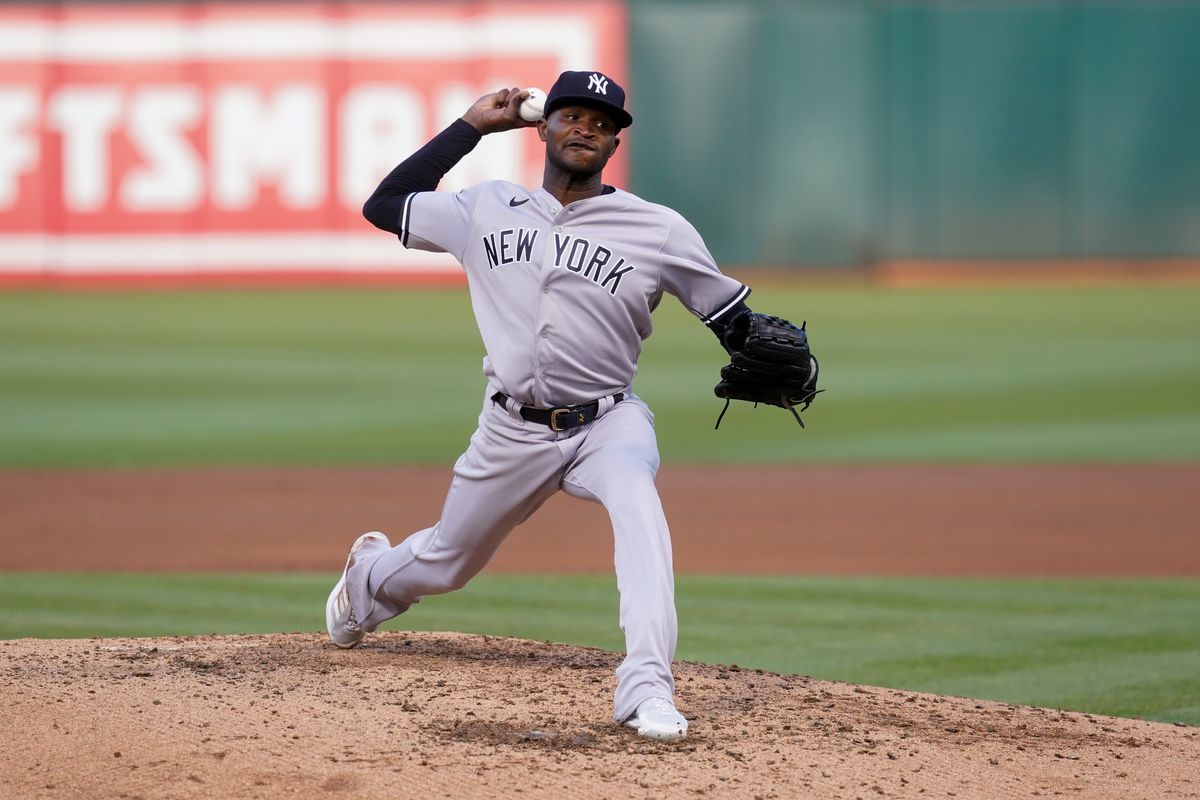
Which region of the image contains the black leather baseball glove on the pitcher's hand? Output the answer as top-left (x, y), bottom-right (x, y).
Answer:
top-left (713, 309), bottom-right (822, 428)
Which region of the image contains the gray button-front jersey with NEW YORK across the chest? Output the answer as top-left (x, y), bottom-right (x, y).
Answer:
top-left (400, 181), bottom-right (750, 408)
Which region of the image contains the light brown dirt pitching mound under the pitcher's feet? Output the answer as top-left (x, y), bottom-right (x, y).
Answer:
top-left (0, 633), bottom-right (1200, 800)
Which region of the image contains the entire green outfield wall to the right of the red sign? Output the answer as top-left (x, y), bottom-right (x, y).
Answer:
top-left (628, 0), bottom-right (1200, 265)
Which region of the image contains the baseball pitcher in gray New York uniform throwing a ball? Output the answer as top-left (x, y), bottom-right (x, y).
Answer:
top-left (326, 72), bottom-right (817, 739)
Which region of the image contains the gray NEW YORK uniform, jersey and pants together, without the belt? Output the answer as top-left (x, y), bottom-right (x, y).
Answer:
top-left (346, 181), bottom-right (750, 721)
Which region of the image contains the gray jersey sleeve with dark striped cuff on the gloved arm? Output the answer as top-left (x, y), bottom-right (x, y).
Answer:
top-left (662, 216), bottom-right (750, 325)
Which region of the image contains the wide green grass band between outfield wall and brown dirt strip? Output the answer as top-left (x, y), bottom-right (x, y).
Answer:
top-left (0, 282), bottom-right (1200, 469)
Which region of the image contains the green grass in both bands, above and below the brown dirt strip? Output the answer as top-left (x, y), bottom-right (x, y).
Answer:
top-left (0, 285), bottom-right (1200, 724)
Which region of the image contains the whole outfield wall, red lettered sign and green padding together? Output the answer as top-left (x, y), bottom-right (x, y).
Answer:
top-left (0, 0), bottom-right (1200, 284)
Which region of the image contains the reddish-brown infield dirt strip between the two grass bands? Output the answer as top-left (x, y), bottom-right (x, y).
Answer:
top-left (0, 464), bottom-right (1200, 579)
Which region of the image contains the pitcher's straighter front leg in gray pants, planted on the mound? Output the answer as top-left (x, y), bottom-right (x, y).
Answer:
top-left (563, 397), bottom-right (678, 722)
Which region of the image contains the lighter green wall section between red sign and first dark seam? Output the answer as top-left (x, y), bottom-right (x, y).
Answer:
top-left (629, 1), bottom-right (875, 264)
